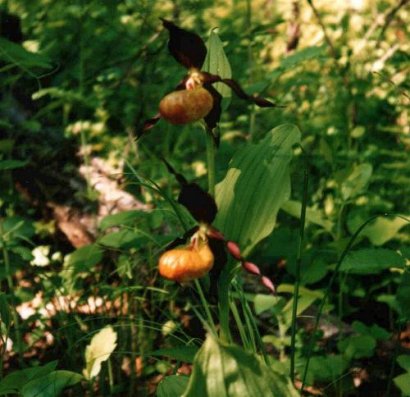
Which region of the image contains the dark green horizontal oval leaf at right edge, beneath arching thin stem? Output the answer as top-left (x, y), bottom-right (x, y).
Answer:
top-left (340, 248), bottom-right (405, 274)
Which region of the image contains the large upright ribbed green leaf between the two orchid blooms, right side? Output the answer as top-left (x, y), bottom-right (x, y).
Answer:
top-left (215, 124), bottom-right (300, 255)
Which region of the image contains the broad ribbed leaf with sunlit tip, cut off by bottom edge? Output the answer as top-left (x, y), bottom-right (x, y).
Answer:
top-left (183, 336), bottom-right (298, 397)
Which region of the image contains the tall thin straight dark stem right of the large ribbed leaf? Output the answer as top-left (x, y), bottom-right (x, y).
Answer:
top-left (290, 166), bottom-right (308, 382)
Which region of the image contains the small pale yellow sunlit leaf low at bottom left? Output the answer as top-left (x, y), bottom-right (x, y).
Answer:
top-left (83, 326), bottom-right (117, 379)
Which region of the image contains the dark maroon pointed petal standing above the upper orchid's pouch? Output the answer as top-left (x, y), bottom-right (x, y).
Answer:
top-left (161, 18), bottom-right (207, 69)
